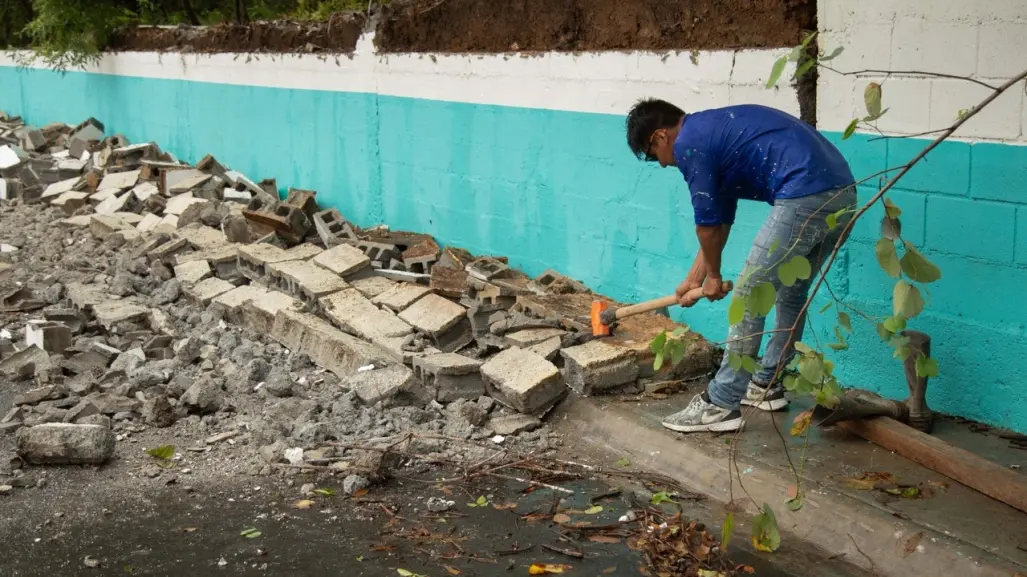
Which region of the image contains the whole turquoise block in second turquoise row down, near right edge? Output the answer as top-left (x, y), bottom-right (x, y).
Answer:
top-left (925, 196), bottom-right (1016, 264)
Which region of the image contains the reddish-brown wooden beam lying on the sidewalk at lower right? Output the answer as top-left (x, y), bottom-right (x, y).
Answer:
top-left (838, 417), bottom-right (1027, 512)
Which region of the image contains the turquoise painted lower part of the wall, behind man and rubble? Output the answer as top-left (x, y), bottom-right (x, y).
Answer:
top-left (0, 68), bottom-right (1027, 431)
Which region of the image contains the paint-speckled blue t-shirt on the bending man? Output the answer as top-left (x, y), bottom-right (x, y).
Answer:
top-left (674, 105), bottom-right (855, 226)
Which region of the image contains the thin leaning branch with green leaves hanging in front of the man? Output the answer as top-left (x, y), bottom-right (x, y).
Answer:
top-left (650, 33), bottom-right (1027, 551)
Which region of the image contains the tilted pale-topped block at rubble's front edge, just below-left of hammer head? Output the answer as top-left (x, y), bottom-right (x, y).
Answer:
top-left (482, 348), bottom-right (567, 415)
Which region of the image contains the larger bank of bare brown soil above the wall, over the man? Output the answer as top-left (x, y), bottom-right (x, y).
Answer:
top-left (376, 0), bottom-right (816, 52)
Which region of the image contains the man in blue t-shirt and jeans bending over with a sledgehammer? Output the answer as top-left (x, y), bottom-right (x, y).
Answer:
top-left (626, 100), bottom-right (855, 432)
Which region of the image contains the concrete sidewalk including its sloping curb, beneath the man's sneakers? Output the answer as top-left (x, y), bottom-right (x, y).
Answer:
top-left (551, 383), bottom-right (1027, 577)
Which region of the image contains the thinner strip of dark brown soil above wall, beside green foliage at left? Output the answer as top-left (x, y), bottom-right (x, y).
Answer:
top-left (110, 12), bottom-right (365, 52)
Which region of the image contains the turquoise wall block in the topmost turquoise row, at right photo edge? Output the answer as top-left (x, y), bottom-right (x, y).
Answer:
top-left (969, 143), bottom-right (1027, 203)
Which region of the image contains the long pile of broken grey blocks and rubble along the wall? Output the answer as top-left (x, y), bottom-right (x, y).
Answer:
top-left (0, 113), bottom-right (717, 480)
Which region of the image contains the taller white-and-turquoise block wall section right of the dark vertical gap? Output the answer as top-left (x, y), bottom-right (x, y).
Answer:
top-left (817, 0), bottom-right (1027, 430)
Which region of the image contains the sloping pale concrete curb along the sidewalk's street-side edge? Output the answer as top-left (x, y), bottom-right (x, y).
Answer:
top-left (550, 396), bottom-right (1024, 577)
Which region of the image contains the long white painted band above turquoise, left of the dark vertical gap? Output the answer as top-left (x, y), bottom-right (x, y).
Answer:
top-left (0, 33), bottom-right (799, 115)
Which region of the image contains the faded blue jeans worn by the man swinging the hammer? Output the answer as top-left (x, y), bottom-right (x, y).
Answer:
top-left (707, 187), bottom-right (855, 410)
